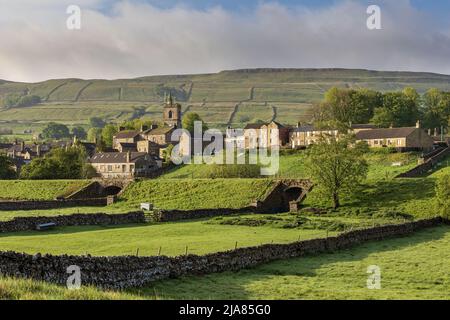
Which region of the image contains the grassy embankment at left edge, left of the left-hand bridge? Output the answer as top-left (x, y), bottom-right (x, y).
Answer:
top-left (0, 180), bottom-right (89, 200)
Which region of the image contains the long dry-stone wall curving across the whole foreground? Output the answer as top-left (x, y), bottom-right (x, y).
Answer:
top-left (0, 218), bottom-right (446, 289)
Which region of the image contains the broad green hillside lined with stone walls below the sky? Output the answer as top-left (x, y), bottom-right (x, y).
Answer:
top-left (0, 69), bottom-right (450, 133)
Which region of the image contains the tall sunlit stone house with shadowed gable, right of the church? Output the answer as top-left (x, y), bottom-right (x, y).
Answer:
top-left (244, 121), bottom-right (289, 149)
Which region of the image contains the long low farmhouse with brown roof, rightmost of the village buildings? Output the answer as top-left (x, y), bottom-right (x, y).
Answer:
top-left (356, 122), bottom-right (434, 151)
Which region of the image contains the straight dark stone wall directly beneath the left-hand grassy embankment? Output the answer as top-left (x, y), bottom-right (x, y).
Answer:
top-left (0, 198), bottom-right (107, 211)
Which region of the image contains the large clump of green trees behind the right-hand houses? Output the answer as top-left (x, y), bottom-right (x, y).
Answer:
top-left (314, 87), bottom-right (450, 132)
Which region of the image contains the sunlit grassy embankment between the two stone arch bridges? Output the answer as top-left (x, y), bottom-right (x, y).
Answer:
top-left (116, 179), bottom-right (273, 210)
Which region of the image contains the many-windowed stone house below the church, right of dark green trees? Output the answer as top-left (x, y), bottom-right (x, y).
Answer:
top-left (89, 152), bottom-right (162, 179)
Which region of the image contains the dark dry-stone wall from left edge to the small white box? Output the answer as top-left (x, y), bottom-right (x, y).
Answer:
top-left (0, 211), bottom-right (145, 232)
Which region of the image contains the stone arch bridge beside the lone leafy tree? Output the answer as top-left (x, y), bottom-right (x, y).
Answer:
top-left (253, 179), bottom-right (313, 213)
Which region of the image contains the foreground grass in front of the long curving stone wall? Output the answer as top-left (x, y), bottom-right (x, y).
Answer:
top-left (0, 226), bottom-right (450, 300)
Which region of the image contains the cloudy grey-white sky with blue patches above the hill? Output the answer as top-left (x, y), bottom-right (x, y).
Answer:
top-left (0, 0), bottom-right (450, 82)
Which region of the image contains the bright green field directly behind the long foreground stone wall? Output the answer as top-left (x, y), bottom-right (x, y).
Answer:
top-left (0, 216), bottom-right (334, 256)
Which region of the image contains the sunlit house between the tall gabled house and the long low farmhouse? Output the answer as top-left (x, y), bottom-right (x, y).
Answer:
top-left (289, 123), bottom-right (339, 149)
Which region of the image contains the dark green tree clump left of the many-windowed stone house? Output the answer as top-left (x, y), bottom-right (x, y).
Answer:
top-left (20, 146), bottom-right (95, 180)
